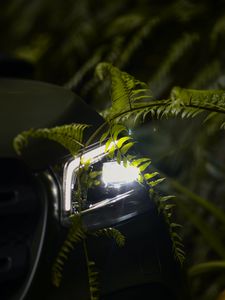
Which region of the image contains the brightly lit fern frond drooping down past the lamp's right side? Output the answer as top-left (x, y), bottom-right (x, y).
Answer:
top-left (99, 124), bottom-right (185, 264)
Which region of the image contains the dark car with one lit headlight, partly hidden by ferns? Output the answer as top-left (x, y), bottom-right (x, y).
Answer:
top-left (0, 74), bottom-right (188, 300)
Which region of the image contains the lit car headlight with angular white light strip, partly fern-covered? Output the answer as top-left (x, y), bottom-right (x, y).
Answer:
top-left (62, 145), bottom-right (151, 230)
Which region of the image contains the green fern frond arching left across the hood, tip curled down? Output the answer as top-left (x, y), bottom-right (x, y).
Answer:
top-left (13, 124), bottom-right (89, 155)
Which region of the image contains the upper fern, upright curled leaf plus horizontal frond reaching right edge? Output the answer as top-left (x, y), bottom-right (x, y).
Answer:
top-left (97, 63), bottom-right (225, 128)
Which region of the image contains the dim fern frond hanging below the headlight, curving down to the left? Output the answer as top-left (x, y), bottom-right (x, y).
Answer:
top-left (52, 215), bottom-right (86, 287)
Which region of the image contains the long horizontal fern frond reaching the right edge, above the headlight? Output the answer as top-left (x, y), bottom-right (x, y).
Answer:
top-left (115, 87), bottom-right (225, 124)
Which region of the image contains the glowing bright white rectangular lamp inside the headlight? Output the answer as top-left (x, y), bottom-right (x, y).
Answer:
top-left (102, 161), bottom-right (139, 185)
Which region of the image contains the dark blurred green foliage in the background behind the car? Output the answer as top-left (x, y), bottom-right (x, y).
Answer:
top-left (0, 0), bottom-right (225, 300)
